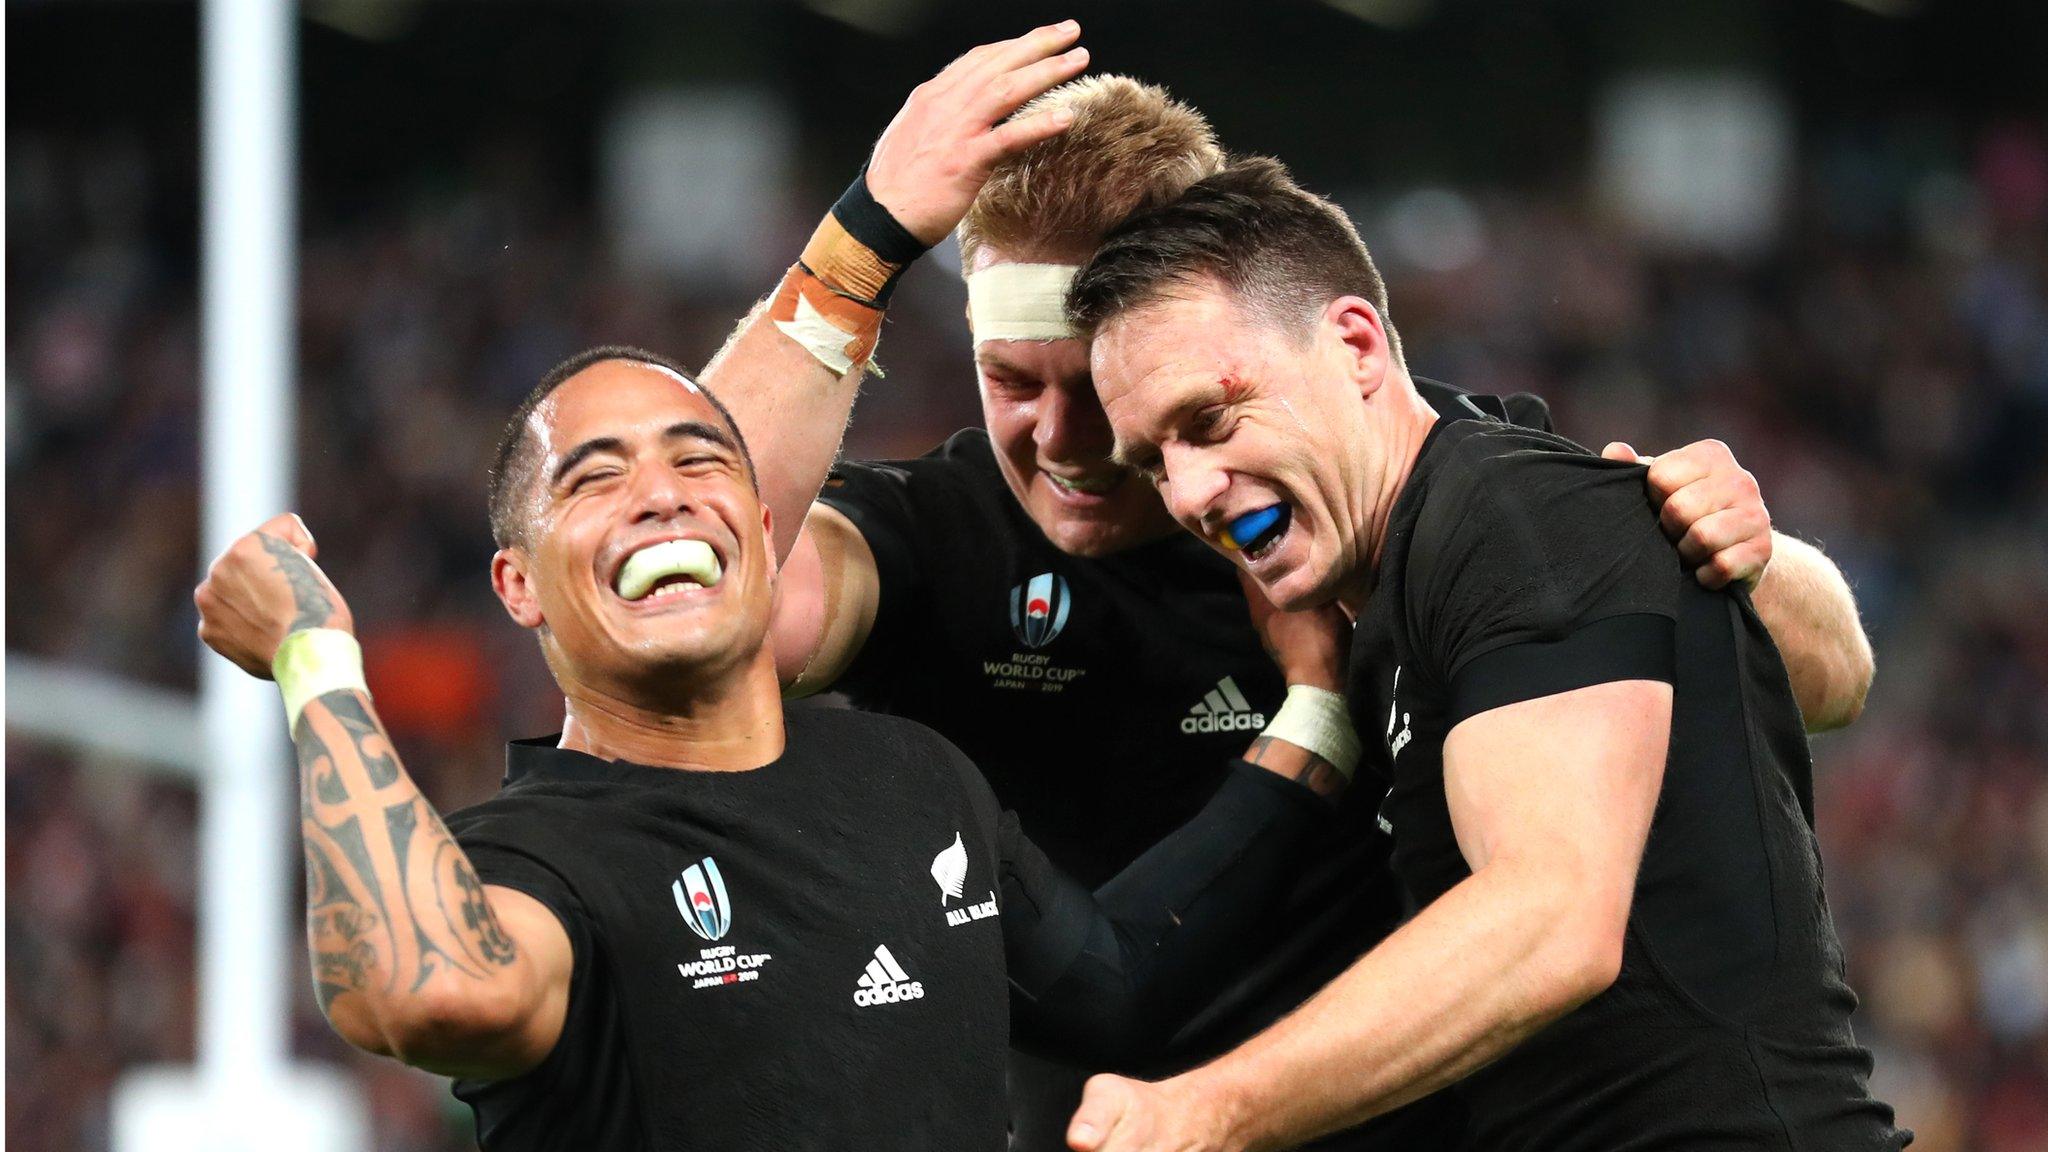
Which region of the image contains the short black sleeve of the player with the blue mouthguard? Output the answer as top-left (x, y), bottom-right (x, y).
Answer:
top-left (1405, 428), bottom-right (1686, 724)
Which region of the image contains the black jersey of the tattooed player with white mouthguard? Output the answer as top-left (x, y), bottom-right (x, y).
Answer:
top-left (449, 705), bottom-right (1327, 1152)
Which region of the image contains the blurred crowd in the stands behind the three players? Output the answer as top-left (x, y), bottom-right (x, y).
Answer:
top-left (6, 105), bottom-right (2048, 1152)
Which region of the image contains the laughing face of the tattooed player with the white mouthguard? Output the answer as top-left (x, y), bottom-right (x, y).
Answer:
top-left (496, 361), bottom-right (772, 699)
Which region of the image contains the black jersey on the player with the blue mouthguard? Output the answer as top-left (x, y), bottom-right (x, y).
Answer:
top-left (1350, 407), bottom-right (1911, 1150)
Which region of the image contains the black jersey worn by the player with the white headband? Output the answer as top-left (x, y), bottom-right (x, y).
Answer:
top-left (819, 379), bottom-right (1550, 1152)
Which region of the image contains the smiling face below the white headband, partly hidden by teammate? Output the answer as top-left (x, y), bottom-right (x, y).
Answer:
top-left (975, 252), bottom-right (1174, 556)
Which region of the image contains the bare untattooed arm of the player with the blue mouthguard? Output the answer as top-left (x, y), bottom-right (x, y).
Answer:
top-left (1071, 681), bottom-right (1671, 1150)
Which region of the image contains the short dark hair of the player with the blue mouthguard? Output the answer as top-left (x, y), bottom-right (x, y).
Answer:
top-left (1067, 156), bottom-right (1401, 363)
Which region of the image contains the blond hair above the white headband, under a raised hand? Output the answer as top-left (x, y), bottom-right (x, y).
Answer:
top-left (961, 76), bottom-right (1225, 266)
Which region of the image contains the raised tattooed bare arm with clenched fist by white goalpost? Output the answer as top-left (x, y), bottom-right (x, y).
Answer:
top-left (193, 515), bottom-right (571, 1078)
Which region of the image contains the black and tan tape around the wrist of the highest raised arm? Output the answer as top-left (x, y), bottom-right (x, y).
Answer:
top-left (768, 168), bottom-right (926, 375)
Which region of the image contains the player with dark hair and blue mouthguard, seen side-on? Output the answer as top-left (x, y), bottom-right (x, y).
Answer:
top-left (1067, 160), bottom-right (1911, 1152)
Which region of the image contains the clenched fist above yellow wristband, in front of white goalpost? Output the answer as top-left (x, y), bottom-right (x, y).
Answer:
top-left (193, 512), bottom-right (356, 681)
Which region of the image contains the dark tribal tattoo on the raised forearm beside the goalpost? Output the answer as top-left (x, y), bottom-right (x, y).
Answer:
top-left (292, 684), bottom-right (522, 1035)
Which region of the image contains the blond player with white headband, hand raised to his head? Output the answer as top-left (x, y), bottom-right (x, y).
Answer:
top-left (707, 23), bottom-right (1870, 1150)
